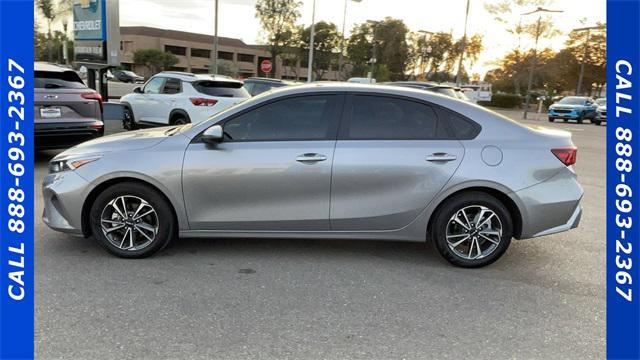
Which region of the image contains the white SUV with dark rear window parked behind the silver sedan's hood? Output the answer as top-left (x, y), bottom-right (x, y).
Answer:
top-left (120, 71), bottom-right (251, 130)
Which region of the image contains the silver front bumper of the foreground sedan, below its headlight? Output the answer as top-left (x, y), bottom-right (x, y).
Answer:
top-left (42, 171), bottom-right (90, 235)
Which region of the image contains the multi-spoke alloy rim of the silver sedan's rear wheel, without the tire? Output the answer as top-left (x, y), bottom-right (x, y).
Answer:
top-left (446, 205), bottom-right (502, 260)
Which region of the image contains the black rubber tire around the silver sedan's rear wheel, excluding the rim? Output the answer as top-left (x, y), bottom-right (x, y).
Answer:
top-left (430, 191), bottom-right (513, 268)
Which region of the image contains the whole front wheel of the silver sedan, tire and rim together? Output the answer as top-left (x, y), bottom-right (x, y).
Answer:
top-left (89, 182), bottom-right (177, 258)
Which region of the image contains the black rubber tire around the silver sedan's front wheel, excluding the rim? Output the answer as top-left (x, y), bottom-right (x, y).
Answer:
top-left (89, 182), bottom-right (178, 259)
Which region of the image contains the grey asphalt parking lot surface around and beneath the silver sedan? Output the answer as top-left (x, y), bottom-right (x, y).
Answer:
top-left (35, 112), bottom-right (605, 359)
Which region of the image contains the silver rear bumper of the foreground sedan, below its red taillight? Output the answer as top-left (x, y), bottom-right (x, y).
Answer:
top-left (513, 168), bottom-right (584, 239)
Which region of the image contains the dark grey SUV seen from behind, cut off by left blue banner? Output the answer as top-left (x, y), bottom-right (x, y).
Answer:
top-left (34, 62), bottom-right (104, 149)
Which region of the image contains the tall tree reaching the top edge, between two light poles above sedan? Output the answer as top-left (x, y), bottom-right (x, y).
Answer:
top-left (256, 0), bottom-right (302, 74)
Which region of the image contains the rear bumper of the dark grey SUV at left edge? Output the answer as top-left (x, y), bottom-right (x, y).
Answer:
top-left (34, 120), bottom-right (104, 149)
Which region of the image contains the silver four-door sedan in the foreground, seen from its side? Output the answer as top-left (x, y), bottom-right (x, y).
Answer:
top-left (43, 83), bottom-right (583, 267)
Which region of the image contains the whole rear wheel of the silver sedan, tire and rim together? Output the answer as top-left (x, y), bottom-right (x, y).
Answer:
top-left (431, 192), bottom-right (513, 268)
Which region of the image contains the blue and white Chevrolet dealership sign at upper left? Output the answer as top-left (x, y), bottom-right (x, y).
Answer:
top-left (73, 0), bottom-right (120, 67)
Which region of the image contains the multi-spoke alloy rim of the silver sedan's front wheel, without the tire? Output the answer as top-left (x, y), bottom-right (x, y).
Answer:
top-left (100, 195), bottom-right (160, 251)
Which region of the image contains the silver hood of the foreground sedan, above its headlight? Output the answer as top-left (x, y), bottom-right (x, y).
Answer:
top-left (58, 126), bottom-right (175, 157)
